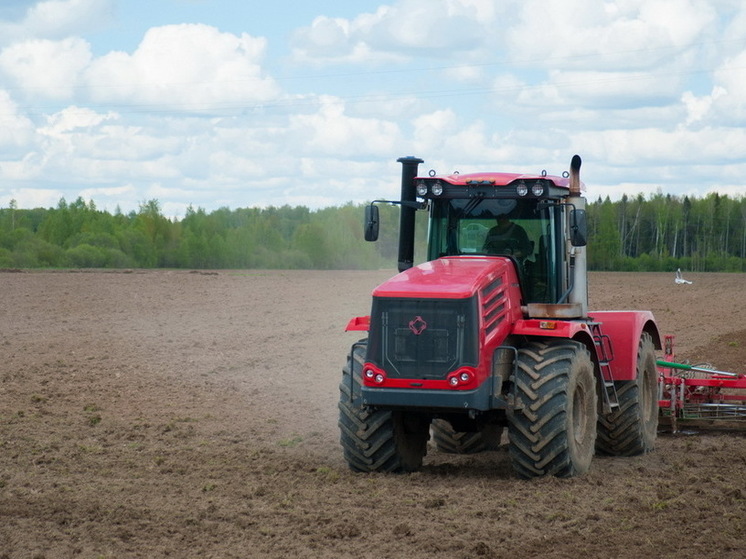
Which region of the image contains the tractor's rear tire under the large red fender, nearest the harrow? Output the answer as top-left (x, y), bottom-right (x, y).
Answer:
top-left (596, 332), bottom-right (658, 456)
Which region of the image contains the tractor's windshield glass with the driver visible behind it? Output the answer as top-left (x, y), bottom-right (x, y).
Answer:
top-left (428, 197), bottom-right (563, 303)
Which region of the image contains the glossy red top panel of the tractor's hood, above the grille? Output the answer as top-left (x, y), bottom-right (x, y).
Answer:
top-left (373, 256), bottom-right (519, 299)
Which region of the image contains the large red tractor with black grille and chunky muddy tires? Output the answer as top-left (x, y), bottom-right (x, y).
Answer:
top-left (339, 155), bottom-right (661, 478)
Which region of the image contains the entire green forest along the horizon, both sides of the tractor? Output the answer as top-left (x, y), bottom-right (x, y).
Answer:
top-left (0, 192), bottom-right (746, 272)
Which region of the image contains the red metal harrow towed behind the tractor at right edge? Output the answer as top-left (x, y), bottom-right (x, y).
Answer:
top-left (657, 335), bottom-right (746, 433)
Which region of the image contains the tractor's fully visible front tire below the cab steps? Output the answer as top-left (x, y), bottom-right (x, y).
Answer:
top-left (508, 339), bottom-right (598, 478)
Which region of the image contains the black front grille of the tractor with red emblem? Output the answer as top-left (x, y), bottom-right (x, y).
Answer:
top-left (367, 298), bottom-right (478, 380)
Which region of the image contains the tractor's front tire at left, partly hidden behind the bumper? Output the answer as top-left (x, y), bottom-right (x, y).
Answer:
top-left (339, 340), bottom-right (430, 472)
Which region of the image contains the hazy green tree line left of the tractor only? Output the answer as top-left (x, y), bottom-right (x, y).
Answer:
top-left (0, 198), bottom-right (406, 269)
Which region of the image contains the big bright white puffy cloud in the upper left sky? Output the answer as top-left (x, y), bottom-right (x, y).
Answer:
top-left (86, 24), bottom-right (280, 113)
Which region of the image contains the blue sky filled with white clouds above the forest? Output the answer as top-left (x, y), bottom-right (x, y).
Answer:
top-left (0, 0), bottom-right (746, 217)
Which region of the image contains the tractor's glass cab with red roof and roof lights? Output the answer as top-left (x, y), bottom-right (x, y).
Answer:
top-left (362, 164), bottom-right (586, 305)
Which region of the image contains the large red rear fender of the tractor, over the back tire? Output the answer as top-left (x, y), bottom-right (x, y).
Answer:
top-left (588, 311), bottom-right (662, 381)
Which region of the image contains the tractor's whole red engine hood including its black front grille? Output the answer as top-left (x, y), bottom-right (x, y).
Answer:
top-left (365, 256), bottom-right (521, 392)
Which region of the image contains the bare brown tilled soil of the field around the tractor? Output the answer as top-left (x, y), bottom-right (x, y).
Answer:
top-left (0, 271), bottom-right (746, 559)
